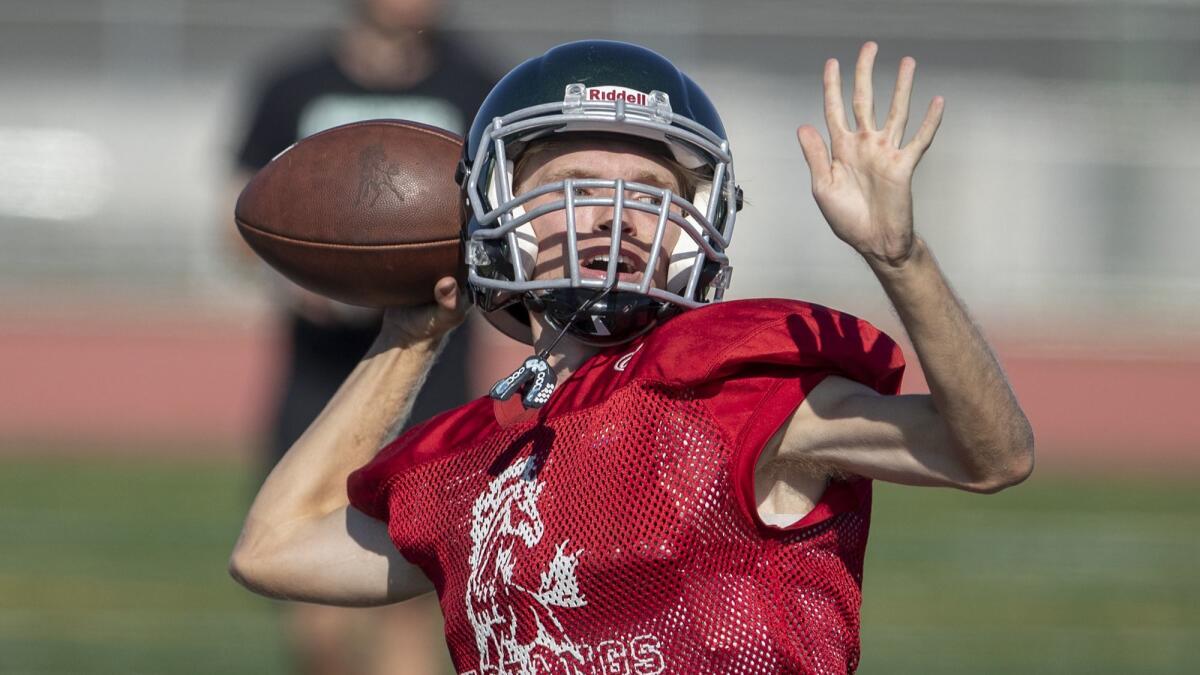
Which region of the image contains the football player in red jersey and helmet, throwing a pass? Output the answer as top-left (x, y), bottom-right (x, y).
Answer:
top-left (230, 41), bottom-right (1033, 674)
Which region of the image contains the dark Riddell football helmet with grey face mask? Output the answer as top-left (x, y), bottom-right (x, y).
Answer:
top-left (460, 40), bottom-right (742, 345)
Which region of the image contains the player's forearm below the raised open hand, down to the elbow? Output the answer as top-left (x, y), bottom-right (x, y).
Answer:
top-left (868, 238), bottom-right (1033, 485)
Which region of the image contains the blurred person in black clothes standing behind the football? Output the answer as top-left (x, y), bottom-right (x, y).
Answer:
top-left (227, 0), bottom-right (494, 675)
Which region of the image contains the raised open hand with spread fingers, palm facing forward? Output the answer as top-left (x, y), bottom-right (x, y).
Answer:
top-left (796, 42), bottom-right (944, 265)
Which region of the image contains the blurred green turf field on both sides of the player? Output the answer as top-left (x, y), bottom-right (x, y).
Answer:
top-left (0, 459), bottom-right (1200, 675)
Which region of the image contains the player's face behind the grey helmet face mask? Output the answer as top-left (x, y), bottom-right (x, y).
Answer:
top-left (514, 139), bottom-right (688, 288)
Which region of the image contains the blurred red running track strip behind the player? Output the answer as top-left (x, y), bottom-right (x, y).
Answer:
top-left (0, 313), bottom-right (1200, 467)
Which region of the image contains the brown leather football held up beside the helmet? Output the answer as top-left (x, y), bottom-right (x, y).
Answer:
top-left (235, 120), bottom-right (463, 307)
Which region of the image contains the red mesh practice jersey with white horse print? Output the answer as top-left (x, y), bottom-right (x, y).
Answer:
top-left (348, 300), bottom-right (904, 675)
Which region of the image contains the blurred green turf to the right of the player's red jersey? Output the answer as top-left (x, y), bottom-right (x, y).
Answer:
top-left (860, 474), bottom-right (1200, 674)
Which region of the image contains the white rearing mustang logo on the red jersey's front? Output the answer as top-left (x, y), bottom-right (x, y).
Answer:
top-left (467, 458), bottom-right (587, 675)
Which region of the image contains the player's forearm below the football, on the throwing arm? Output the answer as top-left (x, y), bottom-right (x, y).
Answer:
top-left (239, 324), bottom-right (442, 545)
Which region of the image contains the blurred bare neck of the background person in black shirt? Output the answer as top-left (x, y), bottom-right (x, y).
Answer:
top-left (336, 20), bottom-right (434, 89)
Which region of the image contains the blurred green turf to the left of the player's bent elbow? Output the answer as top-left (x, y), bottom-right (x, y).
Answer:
top-left (0, 458), bottom-right (287, 674)
